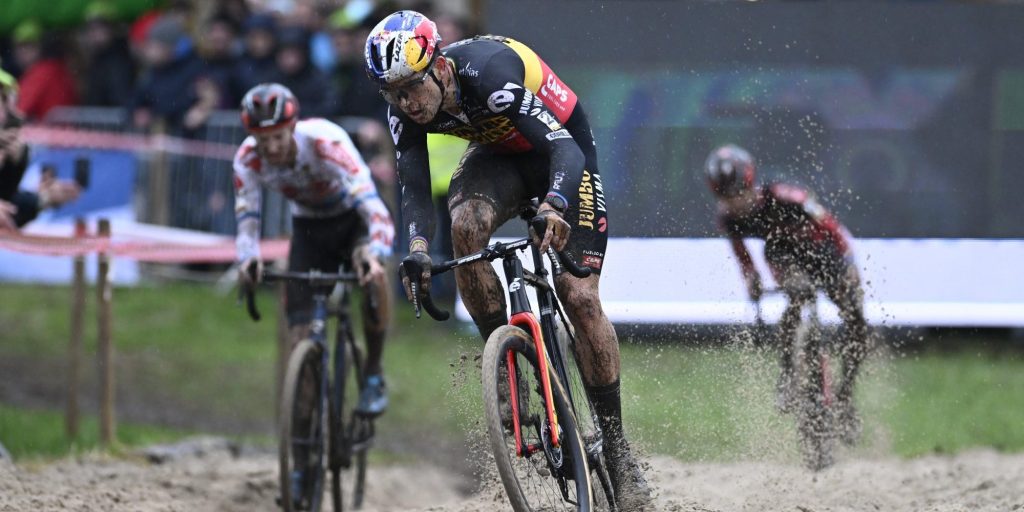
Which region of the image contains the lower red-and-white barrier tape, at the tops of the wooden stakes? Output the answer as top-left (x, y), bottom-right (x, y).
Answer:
top-left (0, 233), bottom-right (289, 263)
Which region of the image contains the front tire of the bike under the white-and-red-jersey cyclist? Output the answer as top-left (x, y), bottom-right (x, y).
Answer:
top-left (278, 339), bottom-right (327, 512)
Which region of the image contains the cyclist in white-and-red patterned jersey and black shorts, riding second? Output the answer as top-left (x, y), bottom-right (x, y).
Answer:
top-left (234, 84), bottom-right (394, 416)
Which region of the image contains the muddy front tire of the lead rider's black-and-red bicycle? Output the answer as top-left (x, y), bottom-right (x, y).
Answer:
top-left (481, 326), bottom-right (593, 512)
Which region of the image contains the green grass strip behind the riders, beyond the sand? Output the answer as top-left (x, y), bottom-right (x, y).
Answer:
top-left (0, 285), bottom-right (1024, 460)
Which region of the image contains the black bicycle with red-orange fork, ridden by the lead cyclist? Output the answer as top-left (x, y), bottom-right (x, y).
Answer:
top-left (402, 207), bottom-right (618, 512)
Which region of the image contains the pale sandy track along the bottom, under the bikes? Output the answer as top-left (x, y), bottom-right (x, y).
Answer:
top-left (0, 438), bottom-right (1024, 512)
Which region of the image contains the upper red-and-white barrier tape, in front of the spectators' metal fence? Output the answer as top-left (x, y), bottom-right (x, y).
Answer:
top-left (22, 125), bottom-right (241, 160)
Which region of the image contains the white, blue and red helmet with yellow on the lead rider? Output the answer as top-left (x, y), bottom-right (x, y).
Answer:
top-left (364, 10), bottom-right (441, 86)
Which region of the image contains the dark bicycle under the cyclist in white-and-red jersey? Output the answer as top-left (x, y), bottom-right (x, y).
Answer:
top-left (245, 268), bottom-right (376, 512)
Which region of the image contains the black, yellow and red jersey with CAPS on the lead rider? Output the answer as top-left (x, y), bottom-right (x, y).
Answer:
top-left (388, 36), bottom-right (595, 246)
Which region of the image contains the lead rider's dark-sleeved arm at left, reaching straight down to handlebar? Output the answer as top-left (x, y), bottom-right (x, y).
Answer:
top-left (388, 109), bottom-right (434, 252)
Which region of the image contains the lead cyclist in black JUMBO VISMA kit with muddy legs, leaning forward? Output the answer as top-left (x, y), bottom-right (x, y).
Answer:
top-left (365, 10), bottom-right (650, 510)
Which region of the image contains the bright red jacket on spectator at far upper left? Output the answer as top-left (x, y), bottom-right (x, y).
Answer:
top-left (17, 58), bottom-right (78, 120)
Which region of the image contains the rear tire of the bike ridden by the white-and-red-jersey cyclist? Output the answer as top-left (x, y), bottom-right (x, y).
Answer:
top-left (329, 333), bottom-right (367, 512)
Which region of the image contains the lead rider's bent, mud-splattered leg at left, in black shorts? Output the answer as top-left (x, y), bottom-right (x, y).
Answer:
top-left (449, 143), bottom-right (528, 340)
